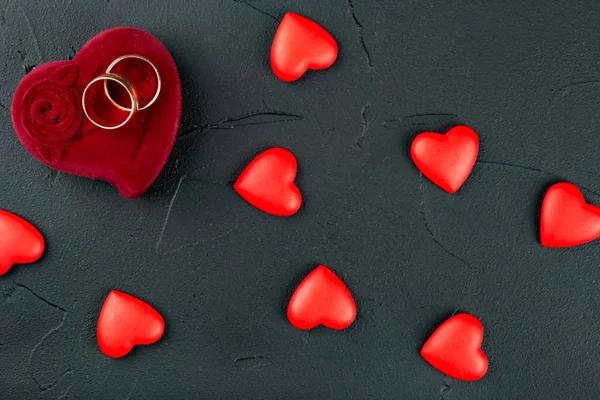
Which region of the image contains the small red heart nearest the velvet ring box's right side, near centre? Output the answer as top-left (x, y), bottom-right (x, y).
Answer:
top-left (233, 147), bottom-right (302, 217)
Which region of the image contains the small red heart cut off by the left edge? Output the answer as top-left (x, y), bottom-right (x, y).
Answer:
top-left (0, 210), bottom-right (44, 275)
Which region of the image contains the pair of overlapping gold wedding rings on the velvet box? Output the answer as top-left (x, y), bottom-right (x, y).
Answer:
top-left (81, 54), bottom-right (162, 129)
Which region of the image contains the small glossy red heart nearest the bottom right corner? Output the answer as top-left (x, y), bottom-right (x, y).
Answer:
top-left (421, 314), bottom-right (488, 381)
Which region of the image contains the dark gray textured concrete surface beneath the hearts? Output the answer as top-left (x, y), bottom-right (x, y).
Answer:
top-left (0, 0), bottom-right (600, 400)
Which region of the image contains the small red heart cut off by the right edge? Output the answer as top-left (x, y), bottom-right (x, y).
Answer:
top-left (540, 182), bottom-right (600, 247)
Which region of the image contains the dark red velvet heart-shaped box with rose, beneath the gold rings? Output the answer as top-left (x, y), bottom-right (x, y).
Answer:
top-left (12, 28), bottom-right (181, 198)
